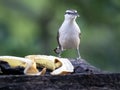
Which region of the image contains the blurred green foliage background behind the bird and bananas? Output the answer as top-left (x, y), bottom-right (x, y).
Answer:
top-left (0, 0), bottom-right (120, 72)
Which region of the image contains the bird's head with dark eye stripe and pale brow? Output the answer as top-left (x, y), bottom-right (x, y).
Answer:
top-left (65, 10), bottom-right (79, 20)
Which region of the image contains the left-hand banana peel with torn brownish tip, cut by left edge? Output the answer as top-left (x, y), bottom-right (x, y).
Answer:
top-left (0, 56), bottom-right (46, 75)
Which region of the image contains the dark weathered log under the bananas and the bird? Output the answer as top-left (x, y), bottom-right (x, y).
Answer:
top-left (0, 59), bottom-right (120, 90)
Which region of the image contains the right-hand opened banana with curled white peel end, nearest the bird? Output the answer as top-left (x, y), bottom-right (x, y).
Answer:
top-left (25, 55), bottom-right (74, 75)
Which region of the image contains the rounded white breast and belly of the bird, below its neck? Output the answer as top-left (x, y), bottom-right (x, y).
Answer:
top-left (59, 26), bottom-right (79, 49)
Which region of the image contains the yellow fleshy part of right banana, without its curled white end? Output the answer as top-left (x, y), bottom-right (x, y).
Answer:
top-left (25, 55), bottom-right (61, 70)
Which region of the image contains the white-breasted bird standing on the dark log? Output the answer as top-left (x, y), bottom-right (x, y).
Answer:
top-left (54, 9), bottom-right (81, 59)
